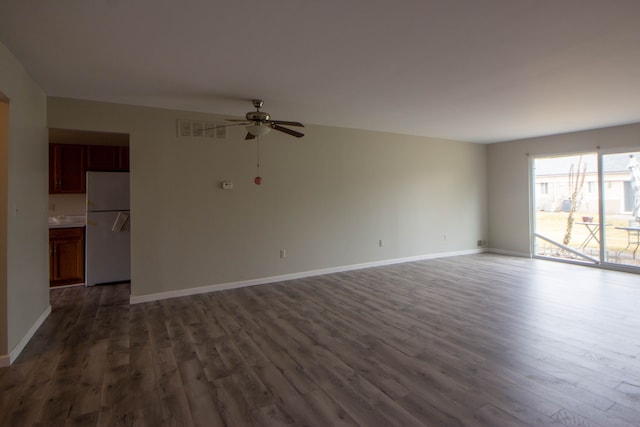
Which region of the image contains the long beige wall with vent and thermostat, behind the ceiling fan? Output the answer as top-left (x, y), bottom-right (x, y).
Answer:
top-left (48, 98), bottom-right (487, 296)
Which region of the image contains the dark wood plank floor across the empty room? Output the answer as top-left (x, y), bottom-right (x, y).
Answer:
top-left (0, 255), bottom-right (640, 427)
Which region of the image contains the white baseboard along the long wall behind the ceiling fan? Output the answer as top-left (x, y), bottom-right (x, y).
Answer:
top-left (129, 249), bottom-right (485, 304)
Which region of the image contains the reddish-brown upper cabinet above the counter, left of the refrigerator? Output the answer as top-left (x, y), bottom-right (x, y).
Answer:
top-left (49, 144), bottom-right (86, 194)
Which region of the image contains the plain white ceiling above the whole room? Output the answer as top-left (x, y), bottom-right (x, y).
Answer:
top-left (0, 0), bottom-right (640, 142)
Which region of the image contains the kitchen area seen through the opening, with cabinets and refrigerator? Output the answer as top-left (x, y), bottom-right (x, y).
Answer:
top-left (49, 129), bottom-right (131, 287)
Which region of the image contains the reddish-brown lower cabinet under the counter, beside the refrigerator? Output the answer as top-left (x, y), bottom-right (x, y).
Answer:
top-left (49, 227), bottom-right (84, 287)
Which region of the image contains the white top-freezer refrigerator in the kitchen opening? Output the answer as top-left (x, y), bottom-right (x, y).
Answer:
top-left (85, 172), bottom-right (131, 286)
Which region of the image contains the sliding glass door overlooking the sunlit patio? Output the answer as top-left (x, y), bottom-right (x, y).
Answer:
top-left (532, 152), bottom-right (640, 269)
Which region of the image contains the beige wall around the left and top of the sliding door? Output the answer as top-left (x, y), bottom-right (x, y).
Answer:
top-left (487, 124), bottom-right (640, 256)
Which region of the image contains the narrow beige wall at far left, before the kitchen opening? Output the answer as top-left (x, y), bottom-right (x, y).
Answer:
top-left (0, 43), bottom-right (49, 355)
